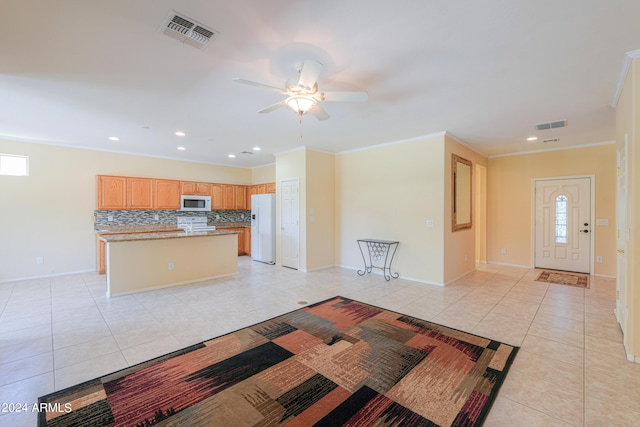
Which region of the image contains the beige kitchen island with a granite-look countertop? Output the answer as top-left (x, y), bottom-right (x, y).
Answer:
top-left (99, 230), bottom-right (238, 297)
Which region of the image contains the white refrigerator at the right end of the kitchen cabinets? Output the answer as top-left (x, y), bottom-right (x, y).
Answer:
top-left (251, 194), bottom-right (276, 264)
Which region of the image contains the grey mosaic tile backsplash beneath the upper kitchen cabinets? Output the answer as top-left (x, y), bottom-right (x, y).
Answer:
top-left (93, 210), bottom-right (251, 227)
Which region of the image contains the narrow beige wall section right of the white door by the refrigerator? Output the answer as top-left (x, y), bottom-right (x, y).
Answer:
top-left (301, 150), bottom-right (335, 271)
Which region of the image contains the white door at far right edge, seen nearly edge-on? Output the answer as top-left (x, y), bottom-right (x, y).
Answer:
top-left (616, 139), bottom-right (629, 333)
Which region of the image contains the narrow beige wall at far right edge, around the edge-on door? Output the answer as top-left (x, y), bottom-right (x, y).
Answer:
top-left (616, 59), bottom-right (640, 362)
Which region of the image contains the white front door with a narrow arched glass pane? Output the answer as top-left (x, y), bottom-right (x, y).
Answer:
top-left (535, 178), bottom-right (593, 273)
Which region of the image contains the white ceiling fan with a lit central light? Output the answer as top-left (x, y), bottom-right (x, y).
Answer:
top-left (233, 59), bottom-right (369, 120)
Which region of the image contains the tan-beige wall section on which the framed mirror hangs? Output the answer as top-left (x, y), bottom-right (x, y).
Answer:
top-left (443, 136), bottom-right (487, 283)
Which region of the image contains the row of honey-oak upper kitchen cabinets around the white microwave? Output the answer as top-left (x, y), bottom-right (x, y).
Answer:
top-left (97, 175), bottom-right (275, 210)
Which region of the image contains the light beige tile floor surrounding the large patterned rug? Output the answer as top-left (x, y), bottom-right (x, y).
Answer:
top-left (0, 257), bottom-right (640, 427)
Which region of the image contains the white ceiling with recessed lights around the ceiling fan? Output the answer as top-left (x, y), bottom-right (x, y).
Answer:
top-left (0, 0), bottom-right (640, 167)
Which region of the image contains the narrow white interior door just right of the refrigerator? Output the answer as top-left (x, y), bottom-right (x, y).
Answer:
top-left (280, 178), bottom-right (300, 269)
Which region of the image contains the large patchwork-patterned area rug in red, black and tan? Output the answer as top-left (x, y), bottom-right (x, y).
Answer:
top-left (38, 297), bottom-right (518, 427)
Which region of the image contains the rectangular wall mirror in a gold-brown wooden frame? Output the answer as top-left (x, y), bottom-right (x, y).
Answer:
top-left (451, 154), bottom-right (472, 231)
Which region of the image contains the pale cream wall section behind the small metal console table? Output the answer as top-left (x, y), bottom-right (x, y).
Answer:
top-left (335, 134), bottom-right (448, 284)
